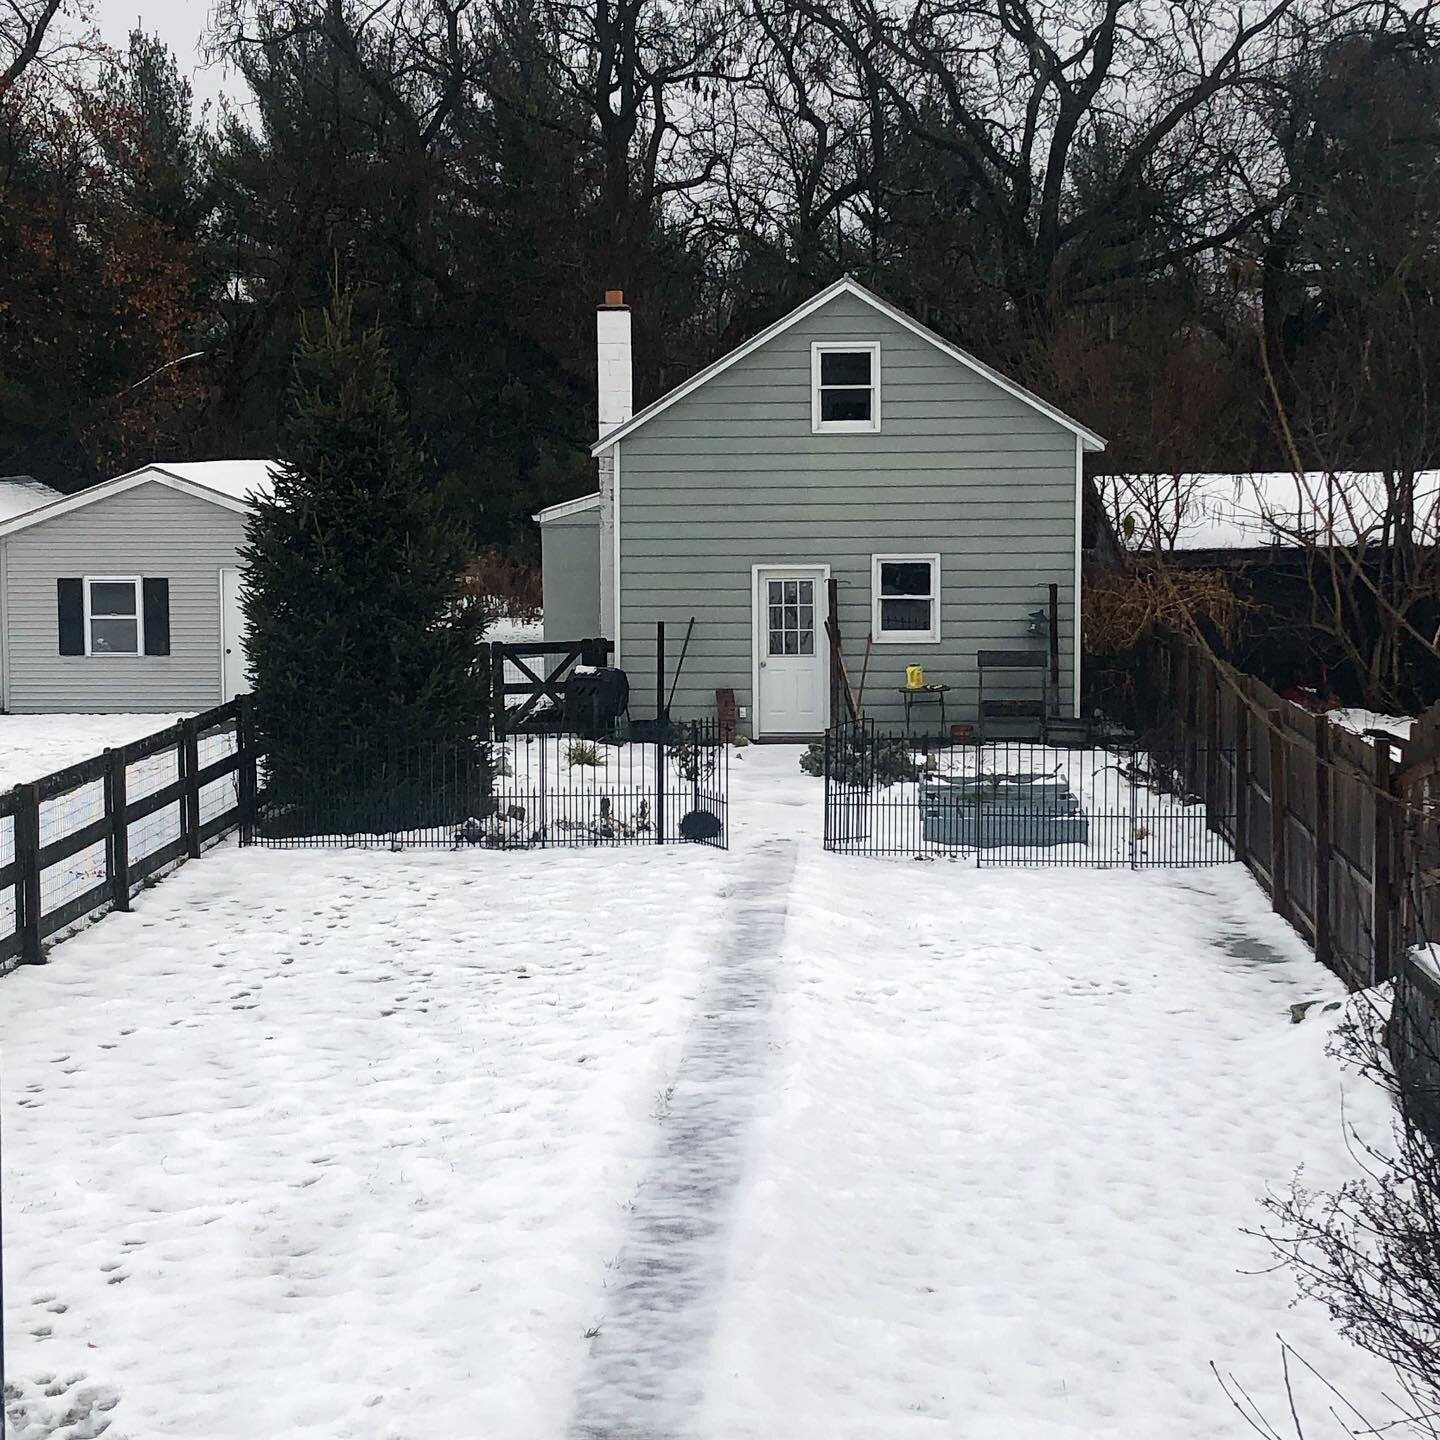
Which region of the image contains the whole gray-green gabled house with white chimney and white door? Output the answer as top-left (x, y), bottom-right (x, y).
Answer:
top-left (536, 278), bottom-right (1104, 739)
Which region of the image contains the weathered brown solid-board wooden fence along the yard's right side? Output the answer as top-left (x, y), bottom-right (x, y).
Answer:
top-left (1161, 642), bottom-right (1440, 988)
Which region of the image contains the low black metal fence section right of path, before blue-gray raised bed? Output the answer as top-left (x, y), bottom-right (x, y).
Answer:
top-left (824, 723), bottom-right (1234, 870)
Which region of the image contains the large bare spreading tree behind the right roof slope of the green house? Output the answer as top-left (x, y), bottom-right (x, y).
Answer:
top-left (798, 0), bottom-right (1336, 311)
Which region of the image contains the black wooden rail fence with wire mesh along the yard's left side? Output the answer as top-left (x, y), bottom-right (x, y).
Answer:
top-left (0, 701), bottom-right (256, 971)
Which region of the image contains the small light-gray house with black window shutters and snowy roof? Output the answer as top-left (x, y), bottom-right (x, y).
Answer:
top-left (0, 461), bottom-right (271, 713)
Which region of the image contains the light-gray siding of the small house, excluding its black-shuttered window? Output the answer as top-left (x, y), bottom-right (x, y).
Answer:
top-left (4, 484), bottom-right (245, 713)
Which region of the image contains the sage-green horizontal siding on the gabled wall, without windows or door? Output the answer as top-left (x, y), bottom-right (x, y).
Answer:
top-left (619, 285), bottom-right (1077, 723)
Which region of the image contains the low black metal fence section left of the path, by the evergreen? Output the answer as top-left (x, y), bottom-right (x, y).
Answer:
top-left (248, 721), bottom-right (730, 850)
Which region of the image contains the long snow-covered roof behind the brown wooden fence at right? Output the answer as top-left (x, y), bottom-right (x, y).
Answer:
top-left (1094, 471), bottom-right (1440, 550)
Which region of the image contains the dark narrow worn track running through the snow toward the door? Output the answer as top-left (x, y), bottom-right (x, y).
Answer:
top-left (569, 841), bottom-right (795, 1440)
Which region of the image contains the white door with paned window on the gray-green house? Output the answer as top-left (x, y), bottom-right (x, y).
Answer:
top-left (755, 564), bottom-right (829, 736)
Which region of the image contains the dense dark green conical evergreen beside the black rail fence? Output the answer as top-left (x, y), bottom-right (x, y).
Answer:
top-left (242, 294), bottom-right (488, 815)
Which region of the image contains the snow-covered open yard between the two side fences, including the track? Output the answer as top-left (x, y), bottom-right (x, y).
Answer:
top-left (0, 747), bottom-right (1387, 1440)
